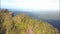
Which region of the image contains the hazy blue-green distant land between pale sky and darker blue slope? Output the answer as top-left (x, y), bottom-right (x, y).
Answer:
top-left (9, 9), bottom-right (60, 20)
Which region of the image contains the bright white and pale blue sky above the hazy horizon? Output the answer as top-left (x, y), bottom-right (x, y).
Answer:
top-left (0, 0), bottom-right (59, 11)
